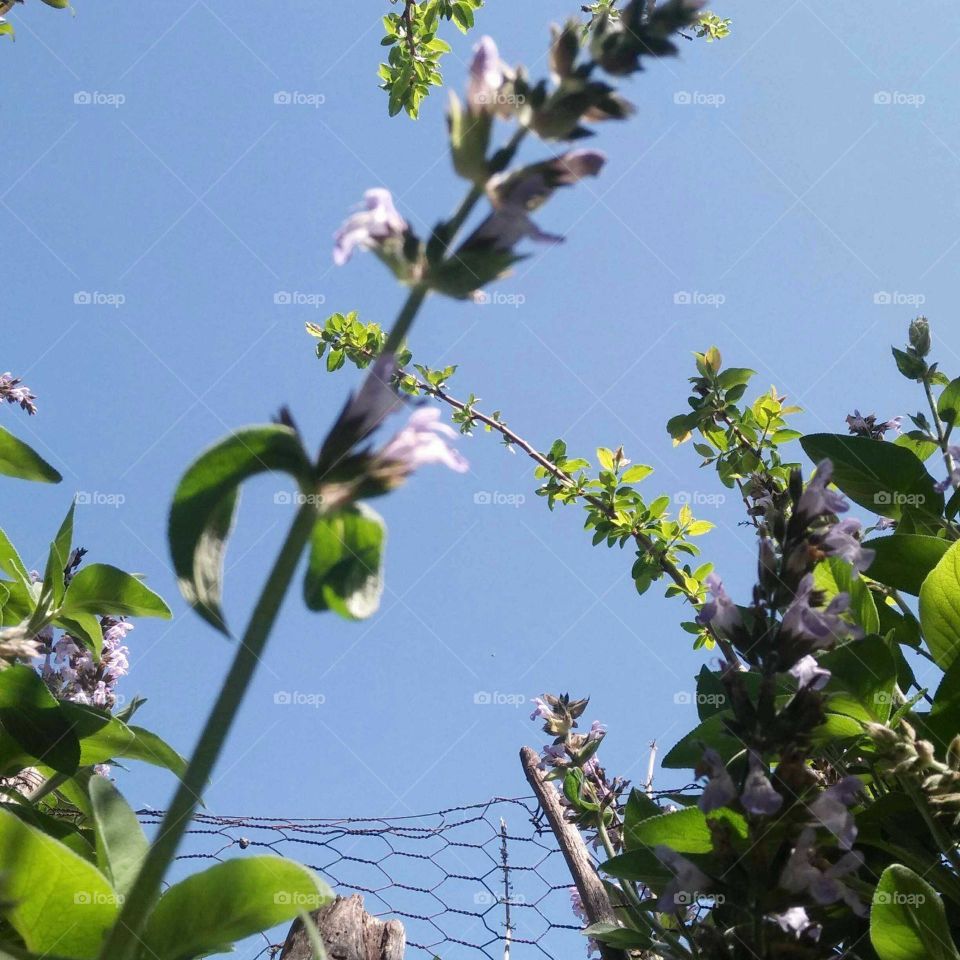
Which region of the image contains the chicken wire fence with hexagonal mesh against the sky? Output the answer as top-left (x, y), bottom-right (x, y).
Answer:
top-left (138, 797), bottom-right (586, 960)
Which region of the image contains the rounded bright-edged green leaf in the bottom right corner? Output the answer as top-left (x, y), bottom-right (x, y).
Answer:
top-left (870, 863), bottom-right (960, 960)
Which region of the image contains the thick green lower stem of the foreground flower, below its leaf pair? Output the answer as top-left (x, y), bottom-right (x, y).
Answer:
top-left (100, 504), bottom-right (316, 960)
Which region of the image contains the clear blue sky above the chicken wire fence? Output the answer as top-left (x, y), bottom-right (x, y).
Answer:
top-left (0, 0), bottom-right (960, 928)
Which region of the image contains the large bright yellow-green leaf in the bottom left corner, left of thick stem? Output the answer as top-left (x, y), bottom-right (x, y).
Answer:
top-left (0, 808), bottom-right (118, 960)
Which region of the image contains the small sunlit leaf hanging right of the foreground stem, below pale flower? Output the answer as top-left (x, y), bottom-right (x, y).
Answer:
top-left (303, 503), bottom-right (386, 620)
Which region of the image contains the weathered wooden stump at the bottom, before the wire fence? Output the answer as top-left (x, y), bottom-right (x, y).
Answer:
top-left (280, 894), bottom-right (407, 960)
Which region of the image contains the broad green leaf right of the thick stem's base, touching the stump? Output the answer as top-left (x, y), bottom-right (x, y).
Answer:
top-left (143, 857), bottom-right (333, 960)
